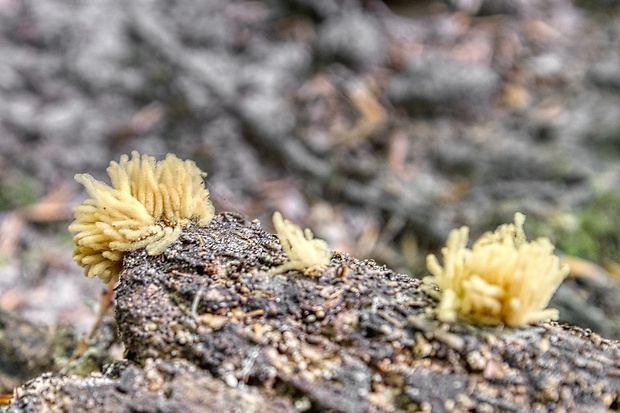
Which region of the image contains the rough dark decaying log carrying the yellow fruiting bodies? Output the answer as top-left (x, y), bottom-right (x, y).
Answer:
top-left (9, 213), bottom-right (620, 413)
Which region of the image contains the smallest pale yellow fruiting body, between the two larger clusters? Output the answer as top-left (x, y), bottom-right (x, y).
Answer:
top-left (269, 211), bottom-right (332, 275)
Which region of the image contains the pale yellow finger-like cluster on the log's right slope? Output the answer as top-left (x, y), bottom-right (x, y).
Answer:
top-left (425, 213), bottom-right (569, 326)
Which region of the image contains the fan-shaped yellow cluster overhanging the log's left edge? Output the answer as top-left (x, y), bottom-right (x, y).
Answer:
top-left (69, 151), bottom-right (214, 283)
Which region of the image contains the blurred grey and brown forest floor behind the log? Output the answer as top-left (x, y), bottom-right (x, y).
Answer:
top-left (0, 0), bottom-right (620, 388)
